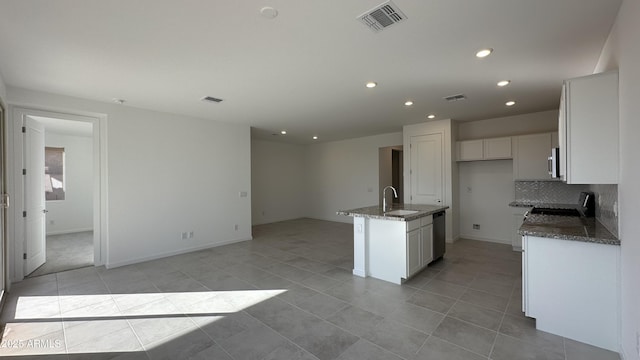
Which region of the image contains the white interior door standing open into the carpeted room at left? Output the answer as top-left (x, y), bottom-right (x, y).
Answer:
top-left (24, 116), bottom-right (47, 274)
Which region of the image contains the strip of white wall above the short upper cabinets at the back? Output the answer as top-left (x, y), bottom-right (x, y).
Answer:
top-left (457, 109), bottom-right (560, 140)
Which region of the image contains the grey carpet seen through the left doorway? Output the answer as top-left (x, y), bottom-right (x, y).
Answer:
top-left (28, 231), bottom-right (93, 277)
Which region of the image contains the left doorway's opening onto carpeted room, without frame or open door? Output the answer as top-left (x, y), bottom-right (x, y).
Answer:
top-left (26, 116), bottom-right (94, 277)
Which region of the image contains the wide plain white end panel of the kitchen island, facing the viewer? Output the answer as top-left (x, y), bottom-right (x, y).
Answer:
top-left (367, 219), bottom-right (407, 284)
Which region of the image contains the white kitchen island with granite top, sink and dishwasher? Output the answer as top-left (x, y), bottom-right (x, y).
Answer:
top-left (337, 204), bottom-right (448, 284)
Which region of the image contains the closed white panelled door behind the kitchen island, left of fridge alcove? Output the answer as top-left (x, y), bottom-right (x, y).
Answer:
top-left (409, 133), bottom-right (444, 205)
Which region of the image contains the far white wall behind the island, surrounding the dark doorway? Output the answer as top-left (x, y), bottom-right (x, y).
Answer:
top-left (307, 133), bottom-right (402, 223)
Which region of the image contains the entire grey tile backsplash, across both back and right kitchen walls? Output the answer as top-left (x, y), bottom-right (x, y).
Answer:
top-left (515, 181), bottom-right (618, 237)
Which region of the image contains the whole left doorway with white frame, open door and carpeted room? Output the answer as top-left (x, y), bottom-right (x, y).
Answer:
top-left (9, 108), bottom-right (106, 281)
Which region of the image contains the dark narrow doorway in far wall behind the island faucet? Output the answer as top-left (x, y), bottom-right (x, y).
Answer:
top-left (378, 145), bottom-right (404, 206)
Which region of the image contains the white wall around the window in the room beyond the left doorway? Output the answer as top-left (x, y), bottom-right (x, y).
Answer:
top-left (44, 132), bottom-right (93, 235)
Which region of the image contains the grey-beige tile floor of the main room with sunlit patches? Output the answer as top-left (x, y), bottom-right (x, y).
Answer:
top-left (0, 219), bottom-right (619, 360)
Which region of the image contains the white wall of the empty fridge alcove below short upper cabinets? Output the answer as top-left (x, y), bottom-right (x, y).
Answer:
top-left (458, 160), bottom-right (514, 244)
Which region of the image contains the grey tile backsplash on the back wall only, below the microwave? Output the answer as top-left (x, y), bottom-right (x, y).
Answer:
top-left (515, 181), bottom-right (589, 204)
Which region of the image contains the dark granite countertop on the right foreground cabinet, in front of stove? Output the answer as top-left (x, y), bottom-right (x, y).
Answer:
top-left (518, 214), bottom-right (620, 245)
